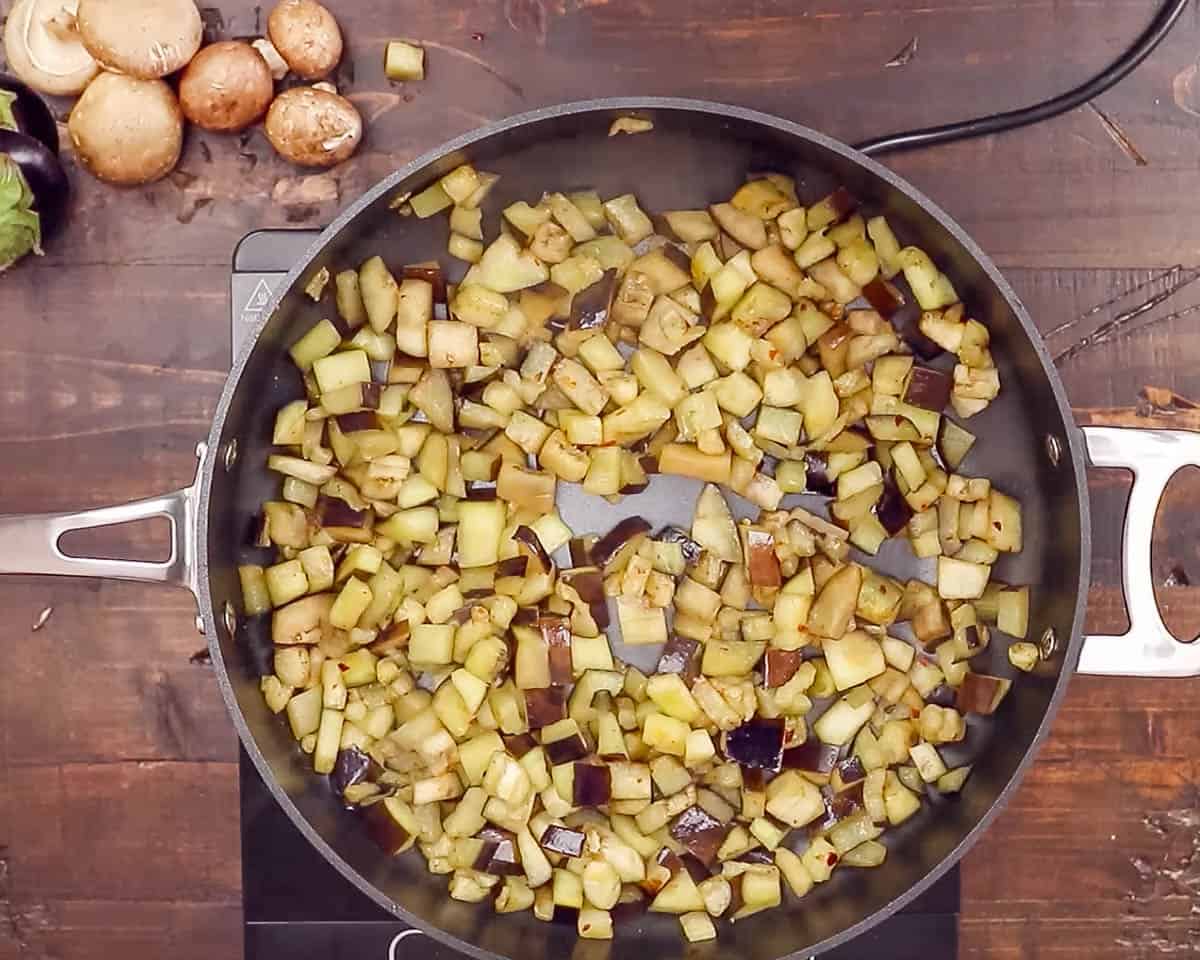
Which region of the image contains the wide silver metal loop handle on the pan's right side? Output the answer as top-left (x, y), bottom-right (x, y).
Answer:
top-left (1079, 427), bottom-right (1200, 677)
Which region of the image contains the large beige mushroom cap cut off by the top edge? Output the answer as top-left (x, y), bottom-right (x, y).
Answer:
top-left (77, 0), bottom-right (204, 80)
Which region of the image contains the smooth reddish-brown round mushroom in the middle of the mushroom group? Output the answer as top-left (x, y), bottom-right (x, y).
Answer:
top-left (179, 40), bottom-right (275, 133)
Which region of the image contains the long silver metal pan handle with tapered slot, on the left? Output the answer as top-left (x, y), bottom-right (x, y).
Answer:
top-left (0, 444), bottom-right (205, 596)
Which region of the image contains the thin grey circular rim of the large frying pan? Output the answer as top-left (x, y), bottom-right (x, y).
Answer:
top-left (197, 97), bottom-right (1092, 960)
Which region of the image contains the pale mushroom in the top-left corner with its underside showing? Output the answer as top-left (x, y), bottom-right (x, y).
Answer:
top-left (4, 0), bottom-right (100, 96)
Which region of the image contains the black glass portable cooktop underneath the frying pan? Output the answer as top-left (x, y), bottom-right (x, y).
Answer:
top-left (230, 230), bottom-right (959, 960)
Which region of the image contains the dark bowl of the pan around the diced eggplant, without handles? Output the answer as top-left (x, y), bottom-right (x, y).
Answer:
top-left (202, 101), bottom-right (1088, 960)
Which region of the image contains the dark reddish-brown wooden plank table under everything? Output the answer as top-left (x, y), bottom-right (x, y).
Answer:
top-left (0, 0), bottom-right (1200, 960)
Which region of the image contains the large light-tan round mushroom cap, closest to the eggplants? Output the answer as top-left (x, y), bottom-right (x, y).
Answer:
top-left (67, 72), bottom-right (184, 186)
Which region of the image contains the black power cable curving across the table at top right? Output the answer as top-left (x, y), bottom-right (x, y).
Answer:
top-left (854, 0), bottom-right (1188, 155)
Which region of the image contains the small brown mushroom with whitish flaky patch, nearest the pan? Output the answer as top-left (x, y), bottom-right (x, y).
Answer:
top-left (266, 86), bottom-right (362, 167)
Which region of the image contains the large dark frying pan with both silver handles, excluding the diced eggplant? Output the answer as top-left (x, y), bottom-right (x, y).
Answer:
top-left (0, 98), bottom-right (1200, 960)
